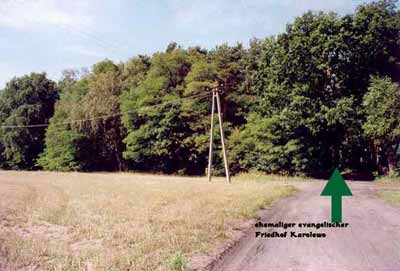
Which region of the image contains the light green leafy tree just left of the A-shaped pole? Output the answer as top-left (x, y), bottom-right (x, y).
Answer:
top-left (121, 48), bottom-right (198, 173)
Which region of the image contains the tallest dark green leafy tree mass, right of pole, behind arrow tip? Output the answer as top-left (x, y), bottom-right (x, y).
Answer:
top-left (234, 1), bottom-right (399, 176)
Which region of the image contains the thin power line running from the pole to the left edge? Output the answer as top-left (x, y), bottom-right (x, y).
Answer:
top-left (0, 93), bottom-right (209, 129)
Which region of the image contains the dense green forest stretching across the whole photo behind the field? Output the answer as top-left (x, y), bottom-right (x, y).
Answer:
top-left (0, 0), bottom-right (400, 176)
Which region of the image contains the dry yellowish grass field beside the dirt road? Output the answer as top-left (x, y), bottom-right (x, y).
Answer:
top-left (0, 171), bottom-right (294, 271)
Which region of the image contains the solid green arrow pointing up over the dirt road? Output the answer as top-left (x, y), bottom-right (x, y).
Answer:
top-left (321, 168), bottom-right (353, 223)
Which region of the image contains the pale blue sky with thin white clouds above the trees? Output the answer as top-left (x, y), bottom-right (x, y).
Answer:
top-left (0, 0), bottom-right (378, 89)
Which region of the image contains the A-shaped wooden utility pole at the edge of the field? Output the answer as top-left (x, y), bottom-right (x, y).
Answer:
top-left (207, 88), bottom-right (231, 183)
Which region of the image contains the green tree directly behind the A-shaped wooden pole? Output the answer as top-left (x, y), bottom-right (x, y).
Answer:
top-left (185, 40), bottom-right (255, 173)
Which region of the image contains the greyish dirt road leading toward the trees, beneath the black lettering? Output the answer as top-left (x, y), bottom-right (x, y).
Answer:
top-left (212, 182), bottom-right (400, 271)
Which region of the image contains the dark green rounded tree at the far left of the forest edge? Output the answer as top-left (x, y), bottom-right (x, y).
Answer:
top-left (0, 73), bottom-right (58, 169)
